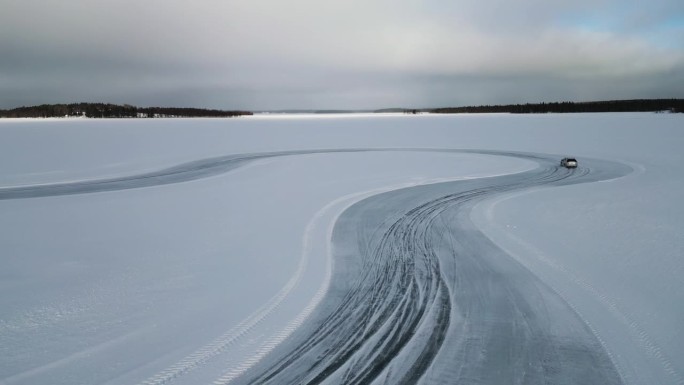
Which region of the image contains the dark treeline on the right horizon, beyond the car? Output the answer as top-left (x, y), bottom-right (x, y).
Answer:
top-left (426, 99), bottom-right (684, 114)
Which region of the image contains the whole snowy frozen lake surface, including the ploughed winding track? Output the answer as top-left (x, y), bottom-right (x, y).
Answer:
top-left (0, 114), bottom-right (684, 385)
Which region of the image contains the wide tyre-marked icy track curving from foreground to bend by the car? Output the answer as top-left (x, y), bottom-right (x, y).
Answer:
top-left (236, 153), bottom-right (630, 384)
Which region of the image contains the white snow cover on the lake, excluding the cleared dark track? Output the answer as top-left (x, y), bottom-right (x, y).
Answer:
top-left (0, 114), bottom-right (684, 384)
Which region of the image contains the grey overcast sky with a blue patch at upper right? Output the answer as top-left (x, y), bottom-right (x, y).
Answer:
top-left (0, 0), bottom-right (684, 110)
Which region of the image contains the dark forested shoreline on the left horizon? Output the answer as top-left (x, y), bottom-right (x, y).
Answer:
top-left (0, 103), bottom-right (252, 118)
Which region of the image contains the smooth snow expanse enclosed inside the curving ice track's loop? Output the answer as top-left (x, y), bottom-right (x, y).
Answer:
top-left (0, 134), bottom-right (529, 384)
